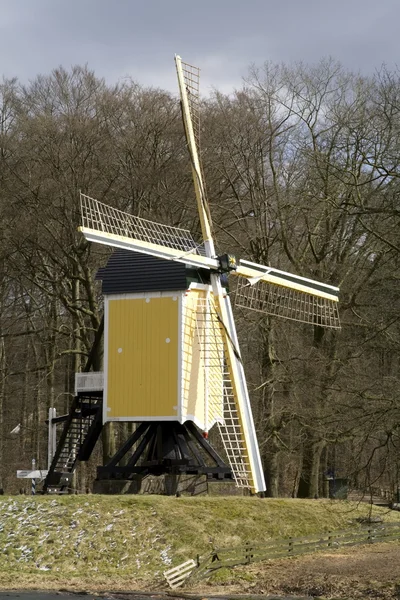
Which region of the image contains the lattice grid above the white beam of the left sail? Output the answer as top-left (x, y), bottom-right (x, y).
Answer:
top-left (80, 193), bottom-right (199, 252)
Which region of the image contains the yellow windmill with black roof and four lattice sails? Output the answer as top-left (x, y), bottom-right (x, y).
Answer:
top-left (74, 56), bottom-right (340, 493)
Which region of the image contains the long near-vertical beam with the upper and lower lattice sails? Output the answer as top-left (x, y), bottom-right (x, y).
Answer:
top-left (175, 56), bottom-right (265, 493)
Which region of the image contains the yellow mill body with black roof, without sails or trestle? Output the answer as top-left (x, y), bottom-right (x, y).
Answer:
top-left (97, 250), bottom-right (224, 431)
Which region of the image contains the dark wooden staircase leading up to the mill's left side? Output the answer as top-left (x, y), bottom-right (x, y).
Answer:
top-left (43, 392), bottom-right (103, 493)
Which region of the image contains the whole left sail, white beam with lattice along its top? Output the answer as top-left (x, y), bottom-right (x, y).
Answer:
top-left (79, 194), bottom-right (218, 269)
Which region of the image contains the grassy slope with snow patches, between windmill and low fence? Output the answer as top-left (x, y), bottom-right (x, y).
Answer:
top-left (0, 496), bottom-right (400, 590)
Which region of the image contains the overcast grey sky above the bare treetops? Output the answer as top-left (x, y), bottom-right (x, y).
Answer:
top-left (0, 0), bottom-right (400, 93)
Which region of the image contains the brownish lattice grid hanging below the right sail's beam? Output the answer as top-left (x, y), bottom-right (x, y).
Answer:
top-left (234, 281), bottom-right (340, 329)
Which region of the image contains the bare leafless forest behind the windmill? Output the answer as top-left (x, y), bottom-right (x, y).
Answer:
top-left (0, 59), bottom-right (400, 498)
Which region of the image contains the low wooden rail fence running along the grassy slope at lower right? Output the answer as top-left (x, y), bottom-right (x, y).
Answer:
top-left (187, 523), bottom-right (400, 581)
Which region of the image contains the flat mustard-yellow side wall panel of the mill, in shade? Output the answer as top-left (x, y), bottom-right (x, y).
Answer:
top-left (106, 296), bottom-right (179, 419)
